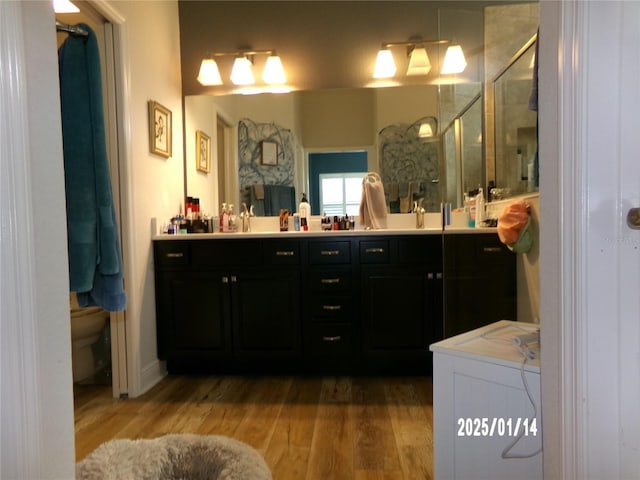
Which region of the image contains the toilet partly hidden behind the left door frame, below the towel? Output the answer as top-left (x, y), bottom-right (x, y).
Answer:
top-left (69, 293), bottom-right (110, 383)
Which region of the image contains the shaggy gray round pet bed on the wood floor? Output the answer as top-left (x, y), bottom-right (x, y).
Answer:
top-left (76, 434), bottom-right (272, 480)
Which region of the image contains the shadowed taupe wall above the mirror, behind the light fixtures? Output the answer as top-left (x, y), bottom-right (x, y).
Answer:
top-left (179, 0), bottom-right (519, 95)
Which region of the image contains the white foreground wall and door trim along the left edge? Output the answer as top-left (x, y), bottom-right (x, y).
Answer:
top-left (0, 2), bottom-right (75, 479)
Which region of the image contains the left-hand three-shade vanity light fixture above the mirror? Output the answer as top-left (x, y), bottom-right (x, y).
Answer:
top-left (198, 50), bottom-right (286, 86)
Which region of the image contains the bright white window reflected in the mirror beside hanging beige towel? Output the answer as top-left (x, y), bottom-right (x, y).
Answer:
top-left (319, 172), bottom-right (367, 216)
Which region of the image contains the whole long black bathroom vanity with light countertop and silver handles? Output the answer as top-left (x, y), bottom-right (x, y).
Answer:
top-left (154, 229), bottom-right (516, 374)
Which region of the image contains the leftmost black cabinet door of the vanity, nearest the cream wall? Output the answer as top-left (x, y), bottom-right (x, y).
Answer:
top-left (162, 272), bottom-right (231, 359)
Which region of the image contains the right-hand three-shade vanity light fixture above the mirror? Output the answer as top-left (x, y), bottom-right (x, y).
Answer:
top-left (373, 39), bottom-right (467, 78)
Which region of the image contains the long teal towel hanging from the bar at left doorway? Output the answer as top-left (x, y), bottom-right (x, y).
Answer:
top-left (58, 24), bottom-right (127, 311)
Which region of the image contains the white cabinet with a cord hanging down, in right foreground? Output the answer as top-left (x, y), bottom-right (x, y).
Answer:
top-left (430, 320), bottom-right (542, 480)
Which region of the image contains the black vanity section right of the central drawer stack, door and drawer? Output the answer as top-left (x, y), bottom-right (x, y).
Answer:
top-left (360, 235), bottom-right (442, 373)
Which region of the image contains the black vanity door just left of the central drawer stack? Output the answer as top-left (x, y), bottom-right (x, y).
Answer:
top-left (231, 269), bottom-right (301, 359)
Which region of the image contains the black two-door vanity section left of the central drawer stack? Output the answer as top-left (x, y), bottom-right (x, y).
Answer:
top-left (154, 240), bottom-right (301, 372)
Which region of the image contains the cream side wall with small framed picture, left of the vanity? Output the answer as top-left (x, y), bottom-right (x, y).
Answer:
top-left (113, 1), bottom-right (184, 396)
